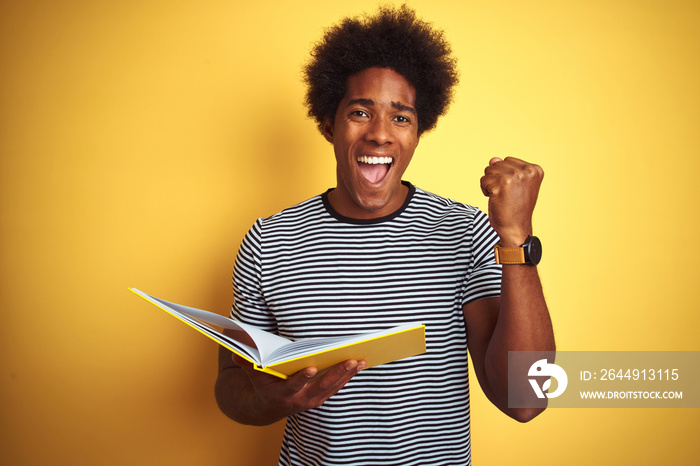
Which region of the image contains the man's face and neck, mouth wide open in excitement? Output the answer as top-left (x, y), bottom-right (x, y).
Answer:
top-left (323, 68), bottom-right (418, 219)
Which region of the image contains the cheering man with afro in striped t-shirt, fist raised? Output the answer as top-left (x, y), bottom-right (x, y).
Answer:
top-left (216, 7), bottom-right (554, 466)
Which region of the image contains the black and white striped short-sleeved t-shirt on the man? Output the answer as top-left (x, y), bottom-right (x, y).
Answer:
top-left (232, 183), bottom-right (501, 466)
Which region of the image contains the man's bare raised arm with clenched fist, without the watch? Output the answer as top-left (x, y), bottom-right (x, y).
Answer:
top-left (464, 157), bottom-right (555, 422)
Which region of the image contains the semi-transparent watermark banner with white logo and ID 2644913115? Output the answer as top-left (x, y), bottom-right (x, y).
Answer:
top-left (508, 351), bottom-right (700, 408)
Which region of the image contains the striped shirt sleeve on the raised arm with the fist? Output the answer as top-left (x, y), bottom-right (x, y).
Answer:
top-left (462, 210), bottom-right (501, 306)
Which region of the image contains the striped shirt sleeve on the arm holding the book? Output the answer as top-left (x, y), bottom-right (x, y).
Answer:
top-left (231, 219), bottom-right (277, 333)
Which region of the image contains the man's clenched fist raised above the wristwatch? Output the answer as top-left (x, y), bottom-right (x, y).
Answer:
top-left (481, 157), bottom-right (544, 247)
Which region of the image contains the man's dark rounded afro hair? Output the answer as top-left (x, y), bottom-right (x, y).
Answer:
top-left (304, 5), bottom-right (459, 136)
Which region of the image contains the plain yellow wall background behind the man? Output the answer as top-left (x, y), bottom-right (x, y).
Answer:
top-left (0, 0), bottom-right (700, 466)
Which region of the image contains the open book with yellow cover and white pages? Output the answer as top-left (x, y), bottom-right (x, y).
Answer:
top-left (129, 288), bottom-right (426, 379)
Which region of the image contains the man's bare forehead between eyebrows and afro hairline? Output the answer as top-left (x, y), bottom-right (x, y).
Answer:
top-left (343, 68), bottom-right (416, 107)
